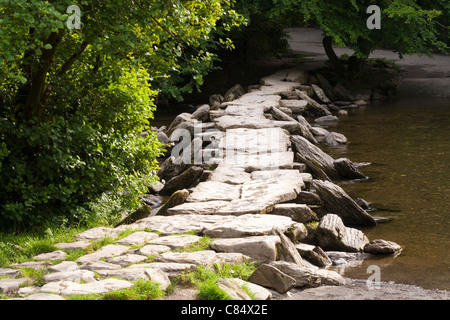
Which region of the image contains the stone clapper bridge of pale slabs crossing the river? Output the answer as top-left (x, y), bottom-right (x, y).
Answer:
top-left (0, 69), bottom-right (400, 299)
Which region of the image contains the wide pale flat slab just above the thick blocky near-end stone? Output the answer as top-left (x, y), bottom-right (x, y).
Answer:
top-left (203, 214), bottom-right (296, 238)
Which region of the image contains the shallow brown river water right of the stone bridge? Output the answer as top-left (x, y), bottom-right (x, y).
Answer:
top-left (325, 99), bottom-right (450, 290)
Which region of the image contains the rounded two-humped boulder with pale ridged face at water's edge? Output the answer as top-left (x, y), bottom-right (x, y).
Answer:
top-left (316, 214), bottom-right (369, 252)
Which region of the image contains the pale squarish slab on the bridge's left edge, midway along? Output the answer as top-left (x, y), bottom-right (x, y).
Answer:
top-left (186, 181), bottom-right (241, 202)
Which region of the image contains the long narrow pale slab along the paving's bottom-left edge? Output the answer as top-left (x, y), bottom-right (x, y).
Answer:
top-left (40, 278), bottom-right (133, 295)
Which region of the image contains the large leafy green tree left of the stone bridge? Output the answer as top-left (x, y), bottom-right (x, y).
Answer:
top-left (0, 0), bottom-right (242, 227)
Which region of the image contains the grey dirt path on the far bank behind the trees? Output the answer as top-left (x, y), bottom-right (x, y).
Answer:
top-left (287, 28), bottom-right (450, 98)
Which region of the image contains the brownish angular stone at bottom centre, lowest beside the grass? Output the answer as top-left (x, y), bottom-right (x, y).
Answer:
top-left (248, 264), bottom-right (296, 293)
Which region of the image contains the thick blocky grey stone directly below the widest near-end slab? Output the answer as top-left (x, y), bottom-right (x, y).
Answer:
top-left (210, 236), bottom-right (280, 262)
